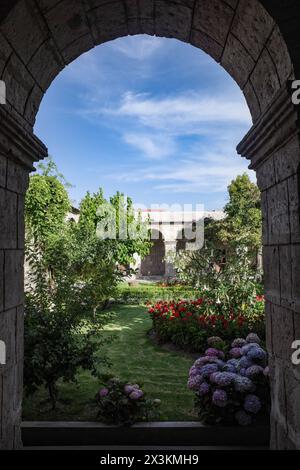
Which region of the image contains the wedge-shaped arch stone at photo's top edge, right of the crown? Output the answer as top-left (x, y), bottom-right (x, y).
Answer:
top-left (193, 0), bottom-right (234, 46)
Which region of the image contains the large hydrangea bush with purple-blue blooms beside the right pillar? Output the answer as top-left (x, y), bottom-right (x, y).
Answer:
top-left (188, 333), bottom-right (270, 426)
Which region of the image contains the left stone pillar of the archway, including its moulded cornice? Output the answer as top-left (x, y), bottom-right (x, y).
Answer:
top-left (0, 106), bottom-right (47, 449)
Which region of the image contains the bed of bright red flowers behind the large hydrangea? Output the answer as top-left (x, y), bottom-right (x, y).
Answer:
top-left (148, 296), bottom-right (265, 352)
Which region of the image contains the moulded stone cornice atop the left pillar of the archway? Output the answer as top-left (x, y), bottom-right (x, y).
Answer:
top-left (0, 105), bottom-right (48, 171)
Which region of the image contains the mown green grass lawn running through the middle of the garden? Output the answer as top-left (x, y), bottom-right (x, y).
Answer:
top-left (23, 306), bottom-right (195, 421)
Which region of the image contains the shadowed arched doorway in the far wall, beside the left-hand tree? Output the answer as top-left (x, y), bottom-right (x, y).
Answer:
top-left (141, 230), bottom-right (166, 277)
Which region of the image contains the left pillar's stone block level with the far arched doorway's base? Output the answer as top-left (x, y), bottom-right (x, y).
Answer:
top-left (4, 250), bottom-right (24, 310)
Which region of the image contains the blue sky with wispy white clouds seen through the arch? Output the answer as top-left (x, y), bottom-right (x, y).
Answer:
top-left (35, 36), bottom-right (254, 210)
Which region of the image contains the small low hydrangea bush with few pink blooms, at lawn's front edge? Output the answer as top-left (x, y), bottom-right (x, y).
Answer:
top-left (96, 378), bottom-right (160, 425)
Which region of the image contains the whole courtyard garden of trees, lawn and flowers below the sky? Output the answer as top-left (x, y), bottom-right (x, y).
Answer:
top-left (23, 161), bottom-right (269, 425)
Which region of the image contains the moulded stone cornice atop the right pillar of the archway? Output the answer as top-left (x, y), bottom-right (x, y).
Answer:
top-left (237, 83), bottom-right (300, 170)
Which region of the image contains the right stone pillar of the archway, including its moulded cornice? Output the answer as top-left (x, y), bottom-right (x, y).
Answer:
top-left (238, 82), bottom-right (300, 449)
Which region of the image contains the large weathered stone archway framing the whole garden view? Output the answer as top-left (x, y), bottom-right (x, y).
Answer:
top-left (0, 0), bottom-right (300, 448)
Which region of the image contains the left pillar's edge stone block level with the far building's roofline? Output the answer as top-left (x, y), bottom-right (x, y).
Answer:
top-left (0, 188), bottom-right (17, 249)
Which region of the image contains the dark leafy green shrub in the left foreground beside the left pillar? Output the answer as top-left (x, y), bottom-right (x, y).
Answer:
top-left (24, 244), bottom-right (109, 409)
